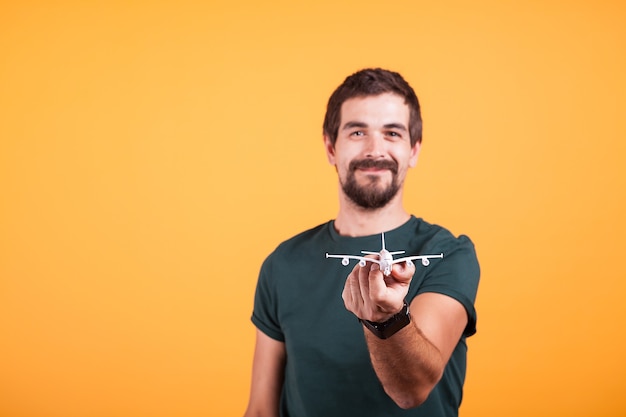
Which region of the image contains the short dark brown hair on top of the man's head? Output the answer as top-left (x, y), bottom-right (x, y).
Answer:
top-left (324, 68), bottom-right (422, 146)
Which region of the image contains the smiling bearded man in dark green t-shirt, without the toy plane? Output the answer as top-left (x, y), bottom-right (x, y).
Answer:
top-left (245, 69), bottom-right (479, 417)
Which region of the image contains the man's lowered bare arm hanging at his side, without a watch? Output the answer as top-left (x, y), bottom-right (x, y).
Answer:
top-left (244, 329), bottom-right (286, 417)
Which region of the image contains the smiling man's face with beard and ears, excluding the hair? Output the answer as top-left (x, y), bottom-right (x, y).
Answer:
top-left (324, 93), bottom-right (420, 209)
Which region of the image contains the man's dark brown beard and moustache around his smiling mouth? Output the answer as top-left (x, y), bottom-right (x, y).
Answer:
top-left (339, 159), bottom-right (400, 210)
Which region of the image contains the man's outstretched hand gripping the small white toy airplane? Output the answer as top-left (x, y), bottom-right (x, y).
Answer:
top-left (341, 256), bottom-right (415, 322)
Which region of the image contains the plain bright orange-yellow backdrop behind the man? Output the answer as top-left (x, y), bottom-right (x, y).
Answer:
top-left (0, 0), bottom-right (626, 417)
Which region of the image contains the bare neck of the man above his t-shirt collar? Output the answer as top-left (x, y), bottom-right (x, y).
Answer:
top-left (335, 193), bottom-right (411, 237)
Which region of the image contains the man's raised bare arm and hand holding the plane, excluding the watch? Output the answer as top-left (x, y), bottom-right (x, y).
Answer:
top-left (343, 262), bottom-right (467, 408)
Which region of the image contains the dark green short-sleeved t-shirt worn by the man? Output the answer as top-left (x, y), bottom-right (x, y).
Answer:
top-left (252, 216), bottom-right (480, 417)
